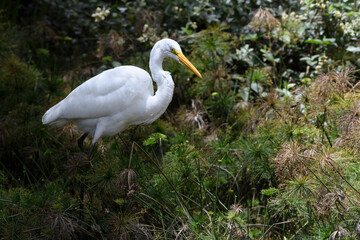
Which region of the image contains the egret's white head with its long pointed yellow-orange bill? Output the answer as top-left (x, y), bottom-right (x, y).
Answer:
top-left (154, 38), bottom-right (202, 78)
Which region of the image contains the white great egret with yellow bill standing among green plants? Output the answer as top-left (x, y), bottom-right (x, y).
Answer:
top-left (42, 39), bottom-right (202, 156)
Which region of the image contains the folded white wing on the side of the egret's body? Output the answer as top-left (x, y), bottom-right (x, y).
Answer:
top-left (59, 66), bottom-right (154, 119)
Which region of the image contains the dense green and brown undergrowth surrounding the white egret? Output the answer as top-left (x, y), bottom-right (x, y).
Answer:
top-left (0, 0), bottom-right (360, 239)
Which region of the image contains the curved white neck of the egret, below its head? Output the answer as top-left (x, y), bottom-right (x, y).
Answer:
top-left (147, 46), bottom-right (174, 121)
